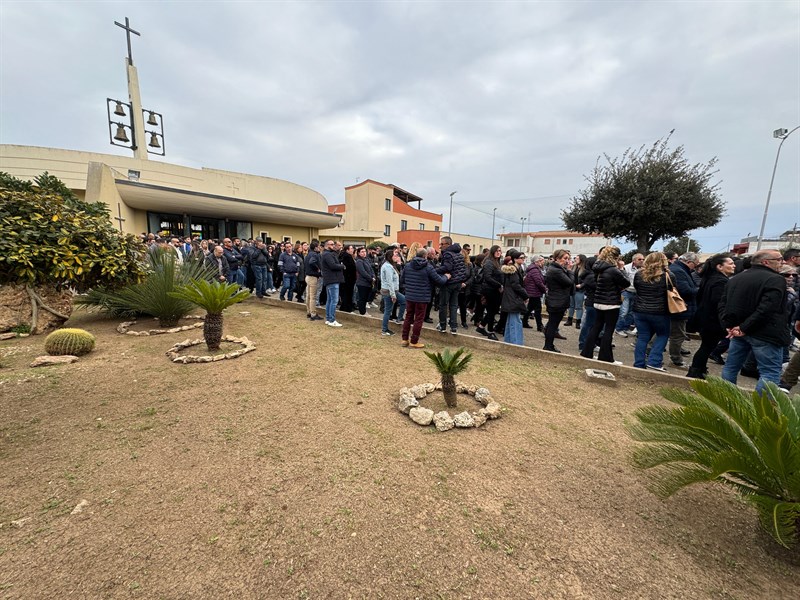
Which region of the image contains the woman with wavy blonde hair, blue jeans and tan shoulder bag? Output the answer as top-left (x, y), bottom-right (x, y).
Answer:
top-left (633, 252), bottom-right (670, 372)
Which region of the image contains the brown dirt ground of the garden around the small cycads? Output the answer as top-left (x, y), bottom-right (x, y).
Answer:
top-left (0, 299), bottom-right (800, 599)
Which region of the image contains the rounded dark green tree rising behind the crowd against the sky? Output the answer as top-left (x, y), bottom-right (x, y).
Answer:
top-left (561, 132), bottom-right (725, 252)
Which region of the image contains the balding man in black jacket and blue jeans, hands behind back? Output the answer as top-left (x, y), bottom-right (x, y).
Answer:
top-left (719, 250), bottom-right (789, 392)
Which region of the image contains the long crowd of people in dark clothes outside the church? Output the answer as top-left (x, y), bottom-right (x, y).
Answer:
top-left (139, 234), bottom-right (800, 390)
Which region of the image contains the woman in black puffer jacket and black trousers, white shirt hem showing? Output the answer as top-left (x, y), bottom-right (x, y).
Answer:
top-left (581, 246), bottom-right (631, 363)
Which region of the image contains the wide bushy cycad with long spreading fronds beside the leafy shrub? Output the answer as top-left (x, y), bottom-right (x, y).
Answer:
top-left (75, 251), bottom-right (214, 327)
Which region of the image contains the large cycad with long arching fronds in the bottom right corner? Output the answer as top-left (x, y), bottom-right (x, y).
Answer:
top-left (627, 377), bottom-right (800, 548)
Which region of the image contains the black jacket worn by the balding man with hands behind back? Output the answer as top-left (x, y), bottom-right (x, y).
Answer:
top-left (719, 265), bottom-right (790, 346)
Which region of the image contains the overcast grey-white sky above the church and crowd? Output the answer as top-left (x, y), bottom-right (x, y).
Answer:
top-left (0, 0), bottom-right (800, 251)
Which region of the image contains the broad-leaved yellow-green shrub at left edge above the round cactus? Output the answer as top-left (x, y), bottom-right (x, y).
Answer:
top-left (0, 172), bottom-right (144, 331)
